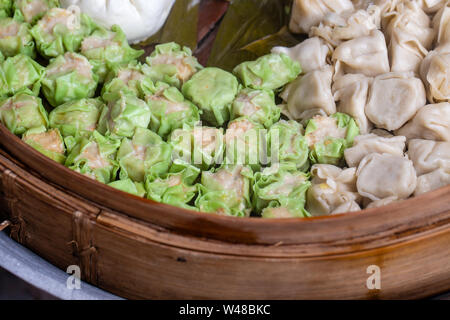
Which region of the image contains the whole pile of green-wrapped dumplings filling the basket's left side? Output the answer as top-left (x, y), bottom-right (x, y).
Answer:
top-left (0, 0), bottom-right (359, 218)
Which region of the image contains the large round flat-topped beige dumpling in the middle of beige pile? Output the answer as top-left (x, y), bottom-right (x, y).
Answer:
top-left (366, 72), bottom-right (426, 131)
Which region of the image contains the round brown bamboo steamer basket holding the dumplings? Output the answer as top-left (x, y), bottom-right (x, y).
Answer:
top-left (0, 4), bottom-right (450, 299)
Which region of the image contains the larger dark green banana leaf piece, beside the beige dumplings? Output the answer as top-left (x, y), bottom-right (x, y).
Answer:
top-left (208, 0), bottom-right (302, 70)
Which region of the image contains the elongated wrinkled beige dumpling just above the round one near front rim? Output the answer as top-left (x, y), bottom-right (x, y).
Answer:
top-left (344, 133), bottom-right (406, 167)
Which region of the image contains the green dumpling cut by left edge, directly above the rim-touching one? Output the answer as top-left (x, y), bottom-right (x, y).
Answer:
top-left (0, 54), bottom-right (45, 96)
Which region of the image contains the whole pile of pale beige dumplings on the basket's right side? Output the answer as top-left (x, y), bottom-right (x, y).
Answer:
top-left (273, 0), bottom-right (450, 214)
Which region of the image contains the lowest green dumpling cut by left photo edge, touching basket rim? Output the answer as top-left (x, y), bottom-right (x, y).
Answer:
top-left (0, 92), bottom-right (48, 135)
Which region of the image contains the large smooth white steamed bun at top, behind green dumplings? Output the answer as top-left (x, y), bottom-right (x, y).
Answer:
top-left (61, 0), bottom-right (175, 43)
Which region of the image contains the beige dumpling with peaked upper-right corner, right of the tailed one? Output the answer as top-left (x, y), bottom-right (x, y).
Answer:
top-left (332, 30), bottom-right (390, 78)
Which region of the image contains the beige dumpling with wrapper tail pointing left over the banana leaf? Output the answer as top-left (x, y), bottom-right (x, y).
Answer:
top-left (272, 37), bottom-right (331, 74)
